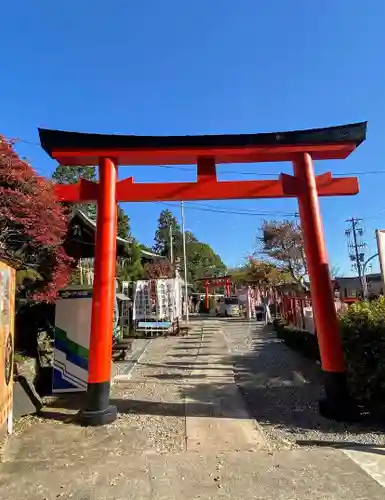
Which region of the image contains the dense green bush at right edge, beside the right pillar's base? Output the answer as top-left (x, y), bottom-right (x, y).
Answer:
top-left (341, 297), bottom-right (385, 412)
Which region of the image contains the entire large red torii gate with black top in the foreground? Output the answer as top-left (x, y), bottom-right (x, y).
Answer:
top-left (39, 122), bottom-right (367, 425)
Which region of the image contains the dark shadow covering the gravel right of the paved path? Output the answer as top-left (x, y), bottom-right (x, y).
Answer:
top-left (226, 327), bottom-right (384, 446)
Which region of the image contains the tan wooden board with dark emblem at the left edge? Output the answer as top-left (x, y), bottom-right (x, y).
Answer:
top-left (0, 262), bottom-right (15, 434)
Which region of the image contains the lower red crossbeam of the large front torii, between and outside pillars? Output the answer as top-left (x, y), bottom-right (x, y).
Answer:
top-left (55, 170), bottom-right (359, 202)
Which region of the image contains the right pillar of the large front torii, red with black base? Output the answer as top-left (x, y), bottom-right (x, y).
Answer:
top-left (293, 153), bottom-right (353, 419)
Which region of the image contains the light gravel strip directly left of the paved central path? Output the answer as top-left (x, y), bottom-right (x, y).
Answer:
top-left (112, 333), bottom-right (201, 454)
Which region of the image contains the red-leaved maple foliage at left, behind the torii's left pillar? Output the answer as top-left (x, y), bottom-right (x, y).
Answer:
top-left (0, 136), bottom-right (72, 302)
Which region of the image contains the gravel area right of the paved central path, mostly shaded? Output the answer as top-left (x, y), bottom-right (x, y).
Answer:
top-left (221, 320), bottom-right (385, 448)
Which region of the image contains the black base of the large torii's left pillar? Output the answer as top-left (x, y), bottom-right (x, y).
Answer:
top-left (78, 382), bottom-right (118, 426)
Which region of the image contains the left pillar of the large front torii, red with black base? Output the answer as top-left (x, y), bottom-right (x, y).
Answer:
top-left (81, 158), bottom-right (117, 425)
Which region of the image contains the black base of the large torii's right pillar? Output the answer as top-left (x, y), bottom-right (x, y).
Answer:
top-left (319, 372), bottom-right (360, 422)
